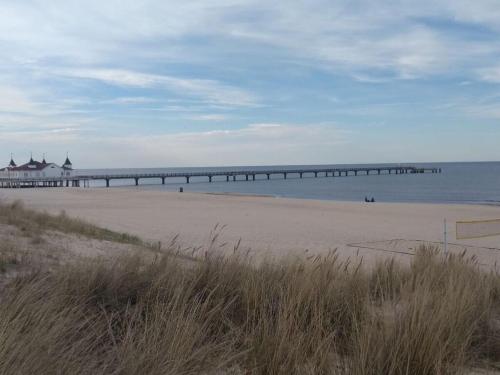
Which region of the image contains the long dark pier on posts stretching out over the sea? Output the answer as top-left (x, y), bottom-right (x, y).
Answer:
top-left (0, 165), bottom-right (441, 188)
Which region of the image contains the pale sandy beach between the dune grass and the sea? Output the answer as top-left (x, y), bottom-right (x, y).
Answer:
top-left (0, 188), bottom-right (500, 265)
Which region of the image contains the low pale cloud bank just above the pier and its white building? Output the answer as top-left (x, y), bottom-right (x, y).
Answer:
top-left (0, 123), bottom-right (349, 168)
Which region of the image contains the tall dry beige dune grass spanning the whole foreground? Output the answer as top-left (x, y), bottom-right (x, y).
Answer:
top-left (0, 242), bottom-right (500, 374)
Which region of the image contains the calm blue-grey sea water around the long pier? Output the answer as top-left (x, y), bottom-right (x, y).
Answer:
top-left (78, 162), bottom-right (500, 205)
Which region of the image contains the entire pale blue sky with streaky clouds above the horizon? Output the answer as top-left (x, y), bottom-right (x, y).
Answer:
top-left (0, 0), bottom-right (500, 168)
